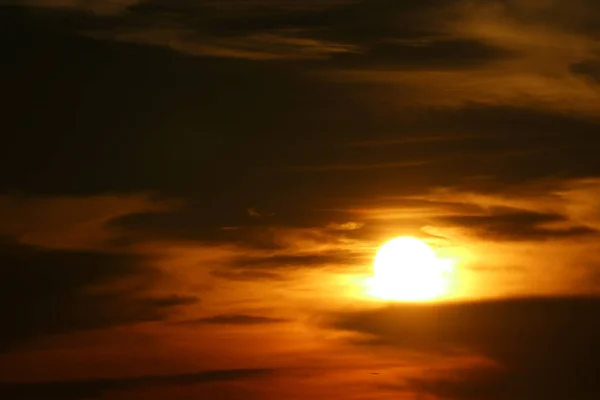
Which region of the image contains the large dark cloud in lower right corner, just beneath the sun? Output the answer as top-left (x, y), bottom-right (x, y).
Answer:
top-left (334, 298), bottom-right (600, 400)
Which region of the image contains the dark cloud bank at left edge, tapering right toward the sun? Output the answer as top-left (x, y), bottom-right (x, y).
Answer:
top-left (0, 236), bottom-right (196, 350)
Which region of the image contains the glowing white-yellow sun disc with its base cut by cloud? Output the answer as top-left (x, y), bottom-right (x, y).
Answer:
top-left (367, 237), bottom-right (453, 301)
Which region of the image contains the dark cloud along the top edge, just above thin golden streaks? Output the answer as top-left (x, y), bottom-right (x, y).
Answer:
top-left (102, 0), bottom-right (440, 46)
